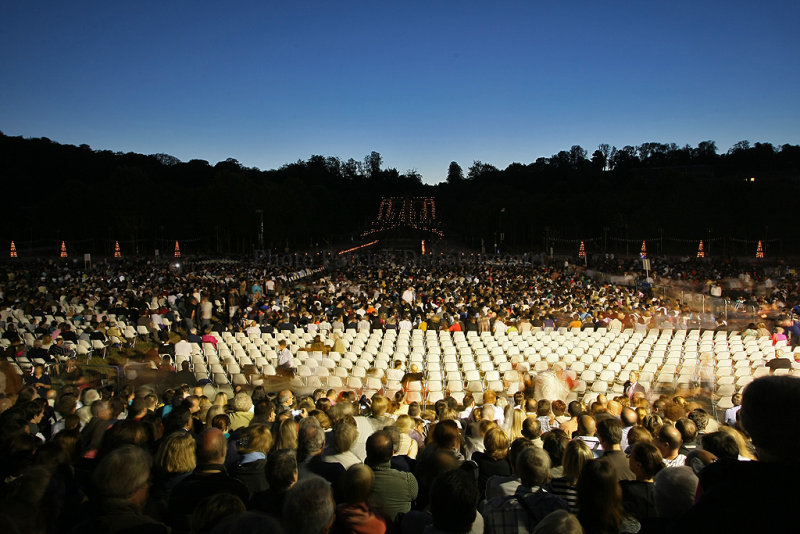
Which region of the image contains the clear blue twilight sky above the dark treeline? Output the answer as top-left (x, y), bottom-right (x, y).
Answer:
top-left (0, 0), bottom-right (800, 183)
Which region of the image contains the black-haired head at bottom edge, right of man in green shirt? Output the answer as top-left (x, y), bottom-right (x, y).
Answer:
top-left (430, 469), bottom-right (480, 532)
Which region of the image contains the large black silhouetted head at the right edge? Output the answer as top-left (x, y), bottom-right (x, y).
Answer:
top-left (740, 375), bottom-right (800, 462)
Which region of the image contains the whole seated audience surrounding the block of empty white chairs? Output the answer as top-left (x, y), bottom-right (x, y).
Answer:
top-left (0, 257), bottom-right (800, 533)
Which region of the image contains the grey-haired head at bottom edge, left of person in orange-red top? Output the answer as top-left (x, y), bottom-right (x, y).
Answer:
top-left (283, 477), bottom-right (335, 534)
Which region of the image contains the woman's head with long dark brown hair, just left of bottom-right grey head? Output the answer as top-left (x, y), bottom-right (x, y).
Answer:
top-left (576, 460), bottom-right (624, 532)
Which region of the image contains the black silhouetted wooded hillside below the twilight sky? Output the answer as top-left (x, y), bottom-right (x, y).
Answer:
top-left (0, 133), bottom-right (800, 256)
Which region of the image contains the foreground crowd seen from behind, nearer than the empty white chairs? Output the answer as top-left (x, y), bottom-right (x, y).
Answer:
top-left (0, 376), bottom-right (800, 534)
